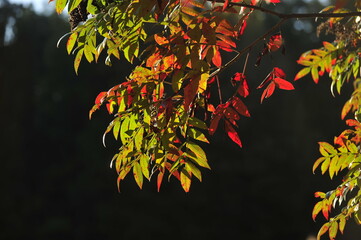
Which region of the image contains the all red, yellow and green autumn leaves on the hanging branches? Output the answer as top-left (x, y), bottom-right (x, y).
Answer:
top-left (55, 0), bottom-right (361, 239)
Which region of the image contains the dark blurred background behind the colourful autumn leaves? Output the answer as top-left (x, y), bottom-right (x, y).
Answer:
top-left (0, 0), bottom-right (361, 240)
